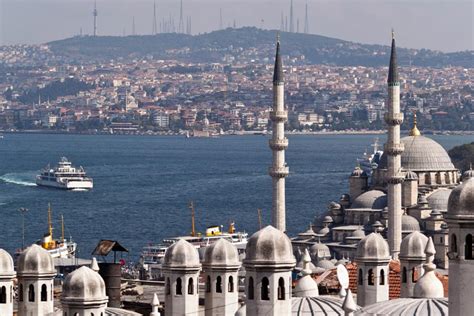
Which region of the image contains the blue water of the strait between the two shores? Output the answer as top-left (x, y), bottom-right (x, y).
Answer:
top-left (0, 134), bottom-right (469, 259)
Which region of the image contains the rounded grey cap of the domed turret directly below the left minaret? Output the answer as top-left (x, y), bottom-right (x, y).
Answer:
top-left (244, 226), bottom-right (296, 267)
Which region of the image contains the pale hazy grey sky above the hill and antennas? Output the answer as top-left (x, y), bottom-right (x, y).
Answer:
top-left (0, 0), bottom-right (474, 51)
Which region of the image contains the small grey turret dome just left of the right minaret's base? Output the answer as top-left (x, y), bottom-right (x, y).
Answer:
top-left (356, 233), bottom-right (390, 261)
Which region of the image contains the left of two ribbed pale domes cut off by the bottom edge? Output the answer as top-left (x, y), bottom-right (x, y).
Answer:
top-left (291, 296), bottom-right (354, 316)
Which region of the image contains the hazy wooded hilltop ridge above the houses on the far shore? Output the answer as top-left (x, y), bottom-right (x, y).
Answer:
top-left (48, 27), bottom-right (474, 68)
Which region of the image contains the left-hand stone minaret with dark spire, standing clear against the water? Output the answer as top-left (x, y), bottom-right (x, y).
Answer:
top-left (269, 37), bottom-right (288, 231)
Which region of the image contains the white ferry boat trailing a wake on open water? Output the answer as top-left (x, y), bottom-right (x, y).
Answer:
top-left (36, 157), bottom-right (93, 191)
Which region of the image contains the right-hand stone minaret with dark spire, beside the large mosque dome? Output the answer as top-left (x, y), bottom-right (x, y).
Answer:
top-left (384, 31), bottom-right (403, 259)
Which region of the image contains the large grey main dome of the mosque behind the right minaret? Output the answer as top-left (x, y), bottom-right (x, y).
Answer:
top-left (379, 136), bottom-right (456, 171)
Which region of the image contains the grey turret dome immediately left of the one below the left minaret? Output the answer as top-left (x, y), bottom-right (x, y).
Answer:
top-left (202, 238), bottom-right (240, 269)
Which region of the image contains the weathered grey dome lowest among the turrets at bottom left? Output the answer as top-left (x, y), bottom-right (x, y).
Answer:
top-left (61, 266), bottom-right (107, 303)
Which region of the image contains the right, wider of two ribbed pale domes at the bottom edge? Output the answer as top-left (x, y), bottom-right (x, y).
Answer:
top-left (355, 297), bottom-right (449, 316)
